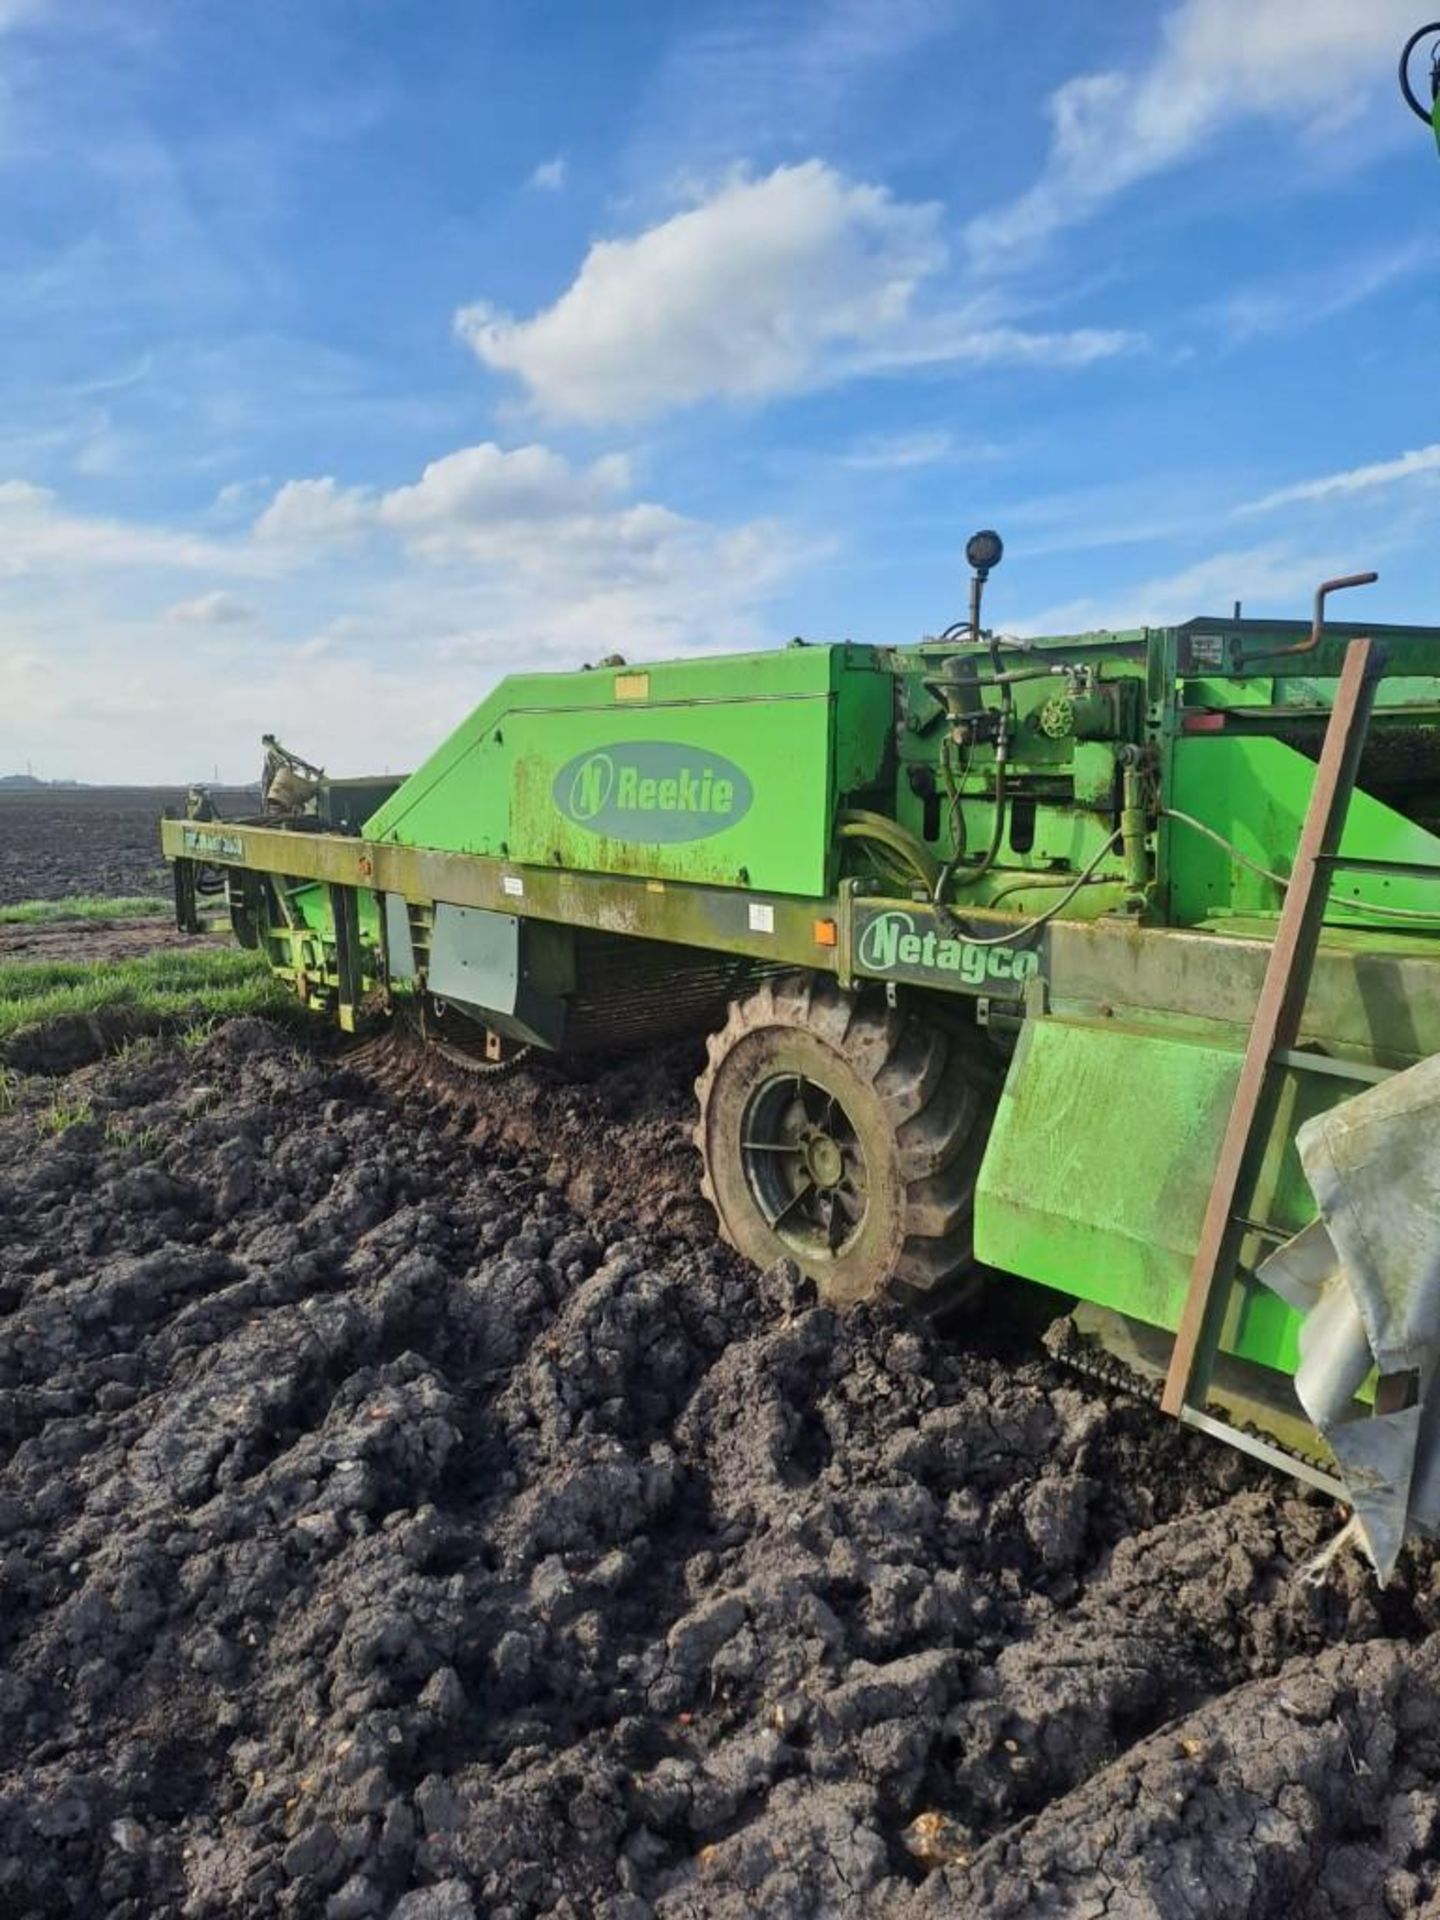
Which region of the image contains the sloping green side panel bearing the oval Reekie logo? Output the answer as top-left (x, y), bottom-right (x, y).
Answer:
top-left (365, 647), bottom-right (891, 895)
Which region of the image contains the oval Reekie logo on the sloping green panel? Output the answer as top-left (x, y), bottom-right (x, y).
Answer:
top-left (553, 739), bottom-right (755, 845)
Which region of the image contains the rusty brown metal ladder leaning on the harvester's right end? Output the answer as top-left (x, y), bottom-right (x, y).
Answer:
top-left (1160, 639), bottom-right (1440, 1498)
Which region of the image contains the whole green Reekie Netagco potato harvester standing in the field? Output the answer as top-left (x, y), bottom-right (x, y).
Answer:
top-left (163, 532), bottom-right (1440, 1576)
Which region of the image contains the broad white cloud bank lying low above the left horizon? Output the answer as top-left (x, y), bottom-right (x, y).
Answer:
top-left (0, 444), bottom-right (826, 780)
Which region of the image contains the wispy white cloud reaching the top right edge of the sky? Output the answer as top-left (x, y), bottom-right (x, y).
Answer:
top-left (970, 0), bottom-right (1415, 263)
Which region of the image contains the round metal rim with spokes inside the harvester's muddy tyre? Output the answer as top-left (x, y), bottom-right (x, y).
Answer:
top-left (739, 1073), bottom-right (868, 1260)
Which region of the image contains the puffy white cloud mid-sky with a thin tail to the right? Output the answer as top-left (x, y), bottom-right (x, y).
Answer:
top-left (455, 159), bottom-right (1131, 422)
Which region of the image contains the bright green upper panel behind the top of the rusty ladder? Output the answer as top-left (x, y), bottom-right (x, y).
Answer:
top-left (1165, 733), bottom-right (1440, 931)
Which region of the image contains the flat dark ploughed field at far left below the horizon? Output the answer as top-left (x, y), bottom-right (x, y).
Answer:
top-left (0, 787), bottom-right (255, 906)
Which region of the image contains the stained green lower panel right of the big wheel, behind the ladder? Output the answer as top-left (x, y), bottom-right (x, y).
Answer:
top-left (975, 1020), bottom-right (1320, 1373)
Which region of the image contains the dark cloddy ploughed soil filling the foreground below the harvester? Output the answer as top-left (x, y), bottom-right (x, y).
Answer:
top-left (0, 1013), bottom-right (1440, 1920)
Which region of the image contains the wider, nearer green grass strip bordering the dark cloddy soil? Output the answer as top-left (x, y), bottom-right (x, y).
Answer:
top-left (0, 947), bottom-right (290, 1039)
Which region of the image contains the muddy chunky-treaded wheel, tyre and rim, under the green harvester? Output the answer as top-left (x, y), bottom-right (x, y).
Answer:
top-left (695, 973), bottom-right (998, 1308)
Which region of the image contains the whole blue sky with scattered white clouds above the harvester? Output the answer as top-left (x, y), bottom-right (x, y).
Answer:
top-left (0, 0), bottom-right (1440, 780)
